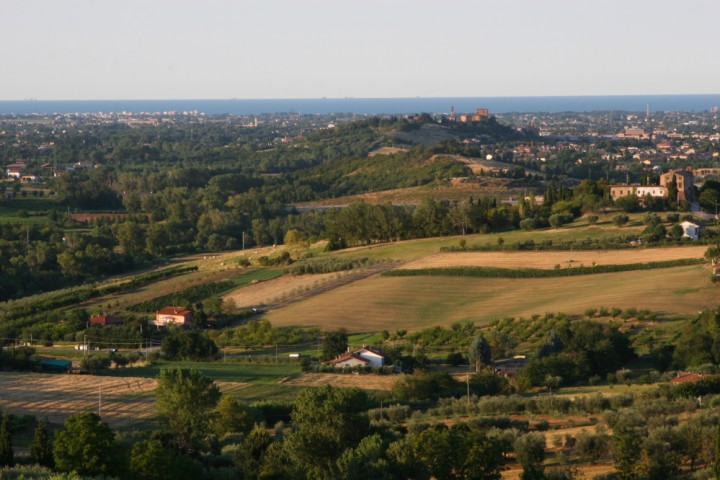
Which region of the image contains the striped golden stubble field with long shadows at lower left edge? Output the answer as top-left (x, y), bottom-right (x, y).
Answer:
top-left (0, 372), bottom-right (157, 428)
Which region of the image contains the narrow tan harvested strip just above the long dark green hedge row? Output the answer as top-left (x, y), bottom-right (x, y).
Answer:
top-left (400, 245), bottom-right (707, 269)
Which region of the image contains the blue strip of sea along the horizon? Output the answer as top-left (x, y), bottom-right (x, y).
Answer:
top-left (0, 94), bottom-right (720, 115)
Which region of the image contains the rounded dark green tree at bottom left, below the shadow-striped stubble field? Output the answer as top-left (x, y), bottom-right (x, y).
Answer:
top-left (53, 412), bottom-right (115, 475)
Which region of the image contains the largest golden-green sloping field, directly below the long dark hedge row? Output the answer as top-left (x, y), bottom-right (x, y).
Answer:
top-left (266, 265), bottom-right (718, 332)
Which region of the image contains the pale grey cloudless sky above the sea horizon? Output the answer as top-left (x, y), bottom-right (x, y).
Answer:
top-left (0, 0), bottom-right (720, 100)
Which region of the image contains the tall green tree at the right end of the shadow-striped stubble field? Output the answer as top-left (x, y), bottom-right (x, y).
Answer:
top-left (155, 368), bottom-right (220, 452)
